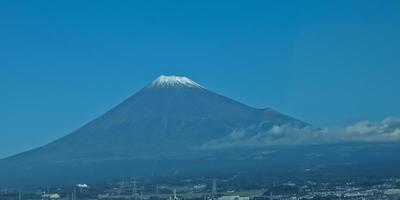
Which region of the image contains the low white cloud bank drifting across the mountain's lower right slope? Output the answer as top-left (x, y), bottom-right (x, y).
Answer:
top-left (203, 117), bottom-right (400, 148)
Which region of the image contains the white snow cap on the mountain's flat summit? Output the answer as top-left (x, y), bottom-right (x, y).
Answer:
top-left (149, 75), bottom-right (204, 88)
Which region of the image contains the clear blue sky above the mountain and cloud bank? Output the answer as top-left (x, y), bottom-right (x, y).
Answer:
top-left (0, 0), bottom-right (400, 157)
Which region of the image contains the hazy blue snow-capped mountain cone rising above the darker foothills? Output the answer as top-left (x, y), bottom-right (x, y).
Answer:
top-left (0, 76), bottom-right (307, 186)
